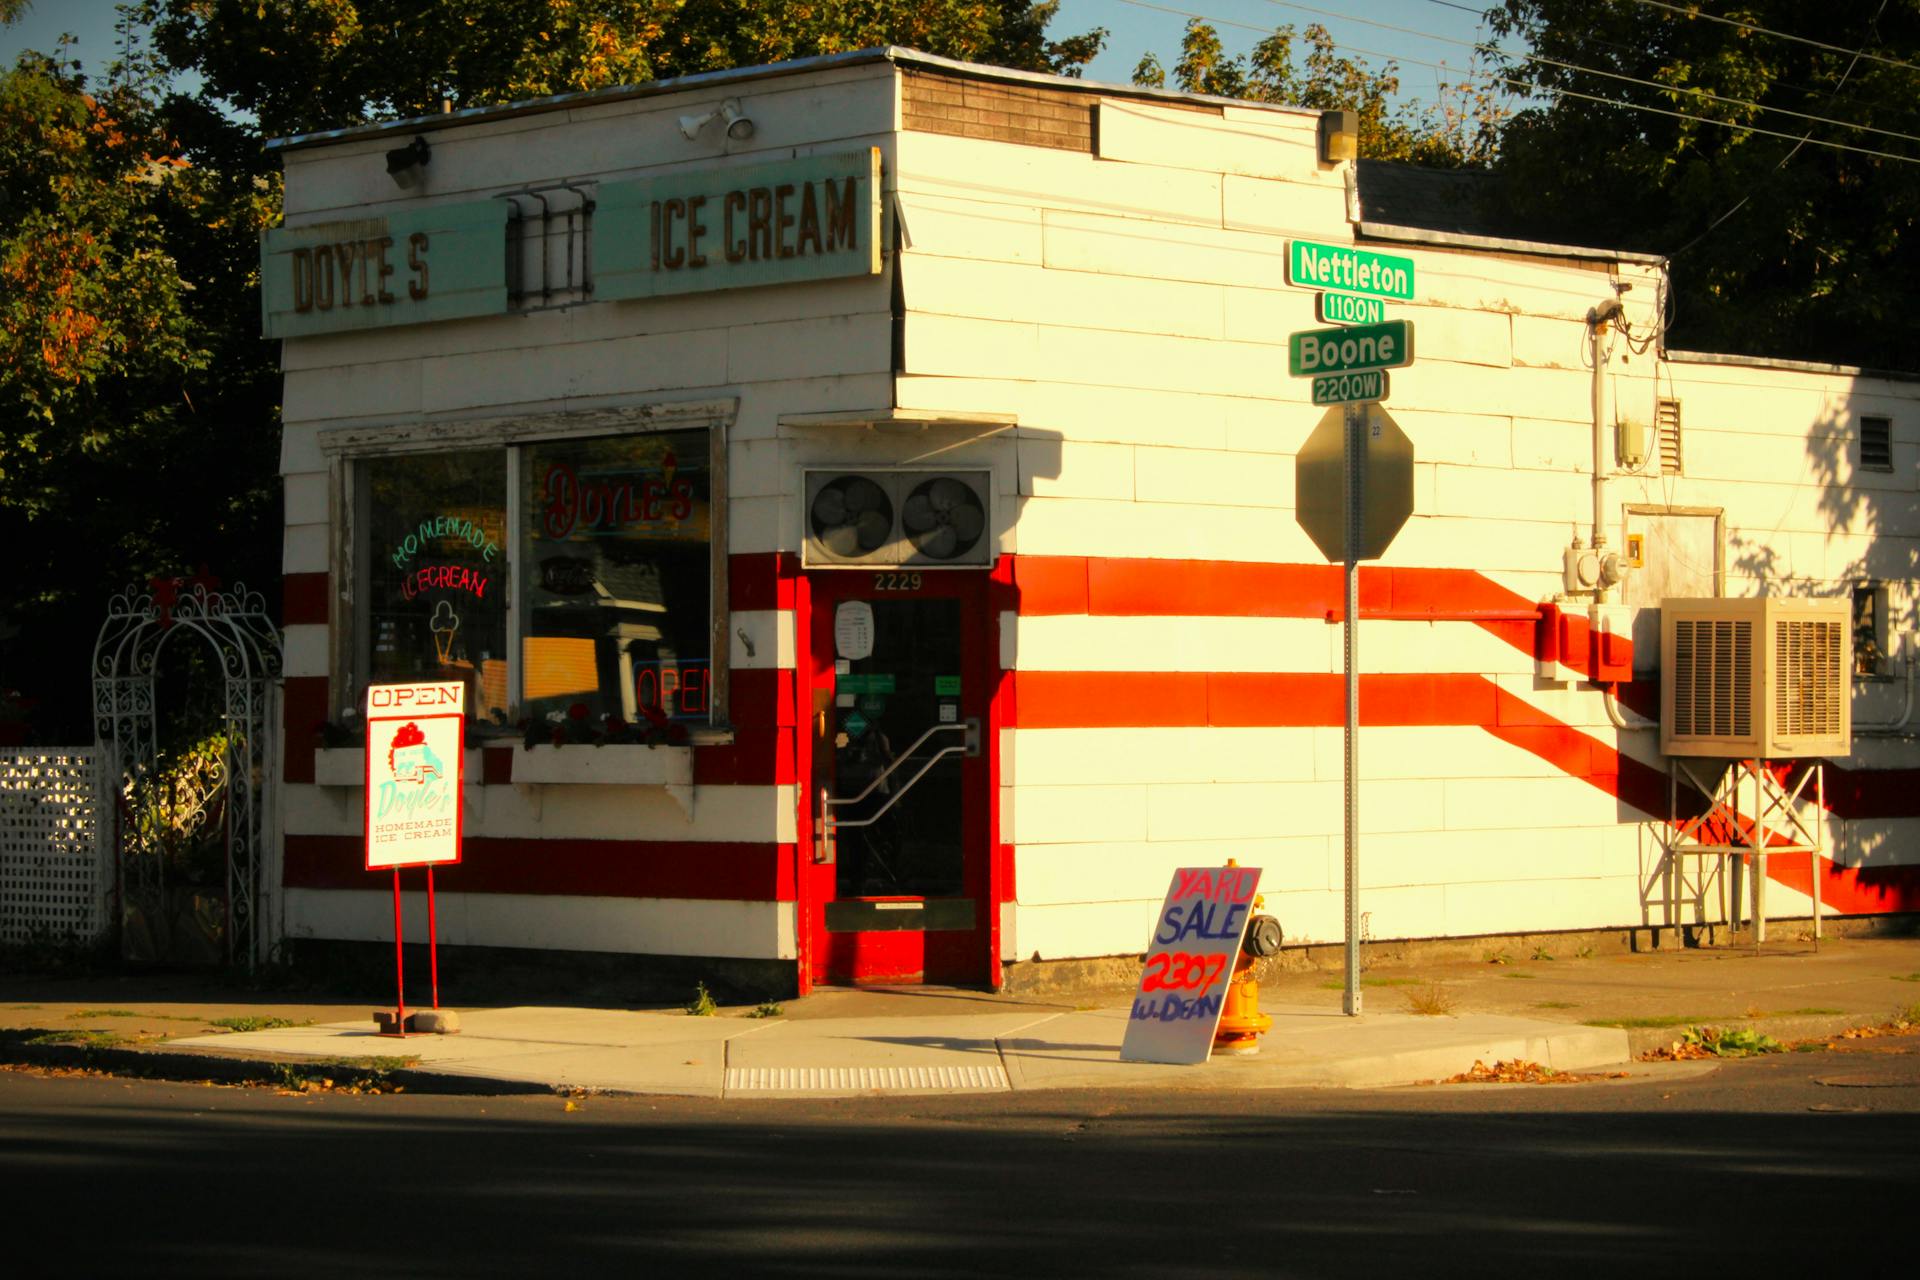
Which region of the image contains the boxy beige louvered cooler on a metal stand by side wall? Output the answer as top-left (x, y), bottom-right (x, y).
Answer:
top-left (1661, 597), bottom-right (1853, 760)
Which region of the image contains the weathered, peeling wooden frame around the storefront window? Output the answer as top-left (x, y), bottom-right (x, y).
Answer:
top-left (319, 397), bottom-right (739, 743)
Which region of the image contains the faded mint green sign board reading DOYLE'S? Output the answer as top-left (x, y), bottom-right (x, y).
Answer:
top-left (259, 200), bottom-right (507, 338)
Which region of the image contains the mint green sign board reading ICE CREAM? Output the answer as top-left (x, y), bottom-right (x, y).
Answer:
top-left (593, 148), bottom-right (879, 299)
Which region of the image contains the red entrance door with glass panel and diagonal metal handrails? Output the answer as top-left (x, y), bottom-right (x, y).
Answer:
top-left (803, 570), bottom-right (995, 984)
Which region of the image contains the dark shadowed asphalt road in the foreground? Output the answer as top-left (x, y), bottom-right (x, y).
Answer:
top-left (0, 1036), bottom-right (1920, 1276)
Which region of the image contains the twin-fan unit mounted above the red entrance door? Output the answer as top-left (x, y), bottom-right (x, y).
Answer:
top-left (801, 468), bottom-right (995, 568)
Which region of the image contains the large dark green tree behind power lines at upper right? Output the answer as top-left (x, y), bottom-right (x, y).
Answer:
top-left (1488, 0), bottom-right (1920, 368)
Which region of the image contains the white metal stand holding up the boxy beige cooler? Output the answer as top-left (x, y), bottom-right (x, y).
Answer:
top-left (1663, 756), bottom-right (1826, 950)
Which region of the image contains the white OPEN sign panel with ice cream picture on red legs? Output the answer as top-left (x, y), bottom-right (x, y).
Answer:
top-left (367, 683), bottom-right (467, 871)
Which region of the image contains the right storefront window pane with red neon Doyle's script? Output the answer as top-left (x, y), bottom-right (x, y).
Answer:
top-left (520, 430), bottom-right (712, 727)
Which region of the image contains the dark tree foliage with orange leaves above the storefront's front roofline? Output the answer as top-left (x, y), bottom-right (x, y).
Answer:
top-left (144, 0), bottom-right (1106, 136)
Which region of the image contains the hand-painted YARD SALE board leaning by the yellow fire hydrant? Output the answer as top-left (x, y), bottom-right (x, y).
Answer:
top-left (1119, 867), bottom-right (1260, 1063)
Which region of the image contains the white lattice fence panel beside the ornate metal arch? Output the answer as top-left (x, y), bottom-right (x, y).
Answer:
top-left (0, 747), bottom-right (111, 942)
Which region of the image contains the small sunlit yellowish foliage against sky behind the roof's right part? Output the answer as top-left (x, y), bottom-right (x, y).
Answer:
top-left (1133, 17), bottom-right (1501, 169)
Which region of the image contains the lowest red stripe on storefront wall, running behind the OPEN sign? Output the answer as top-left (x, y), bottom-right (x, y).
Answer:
top-left (286, 835), bottom-right (793, 902)
